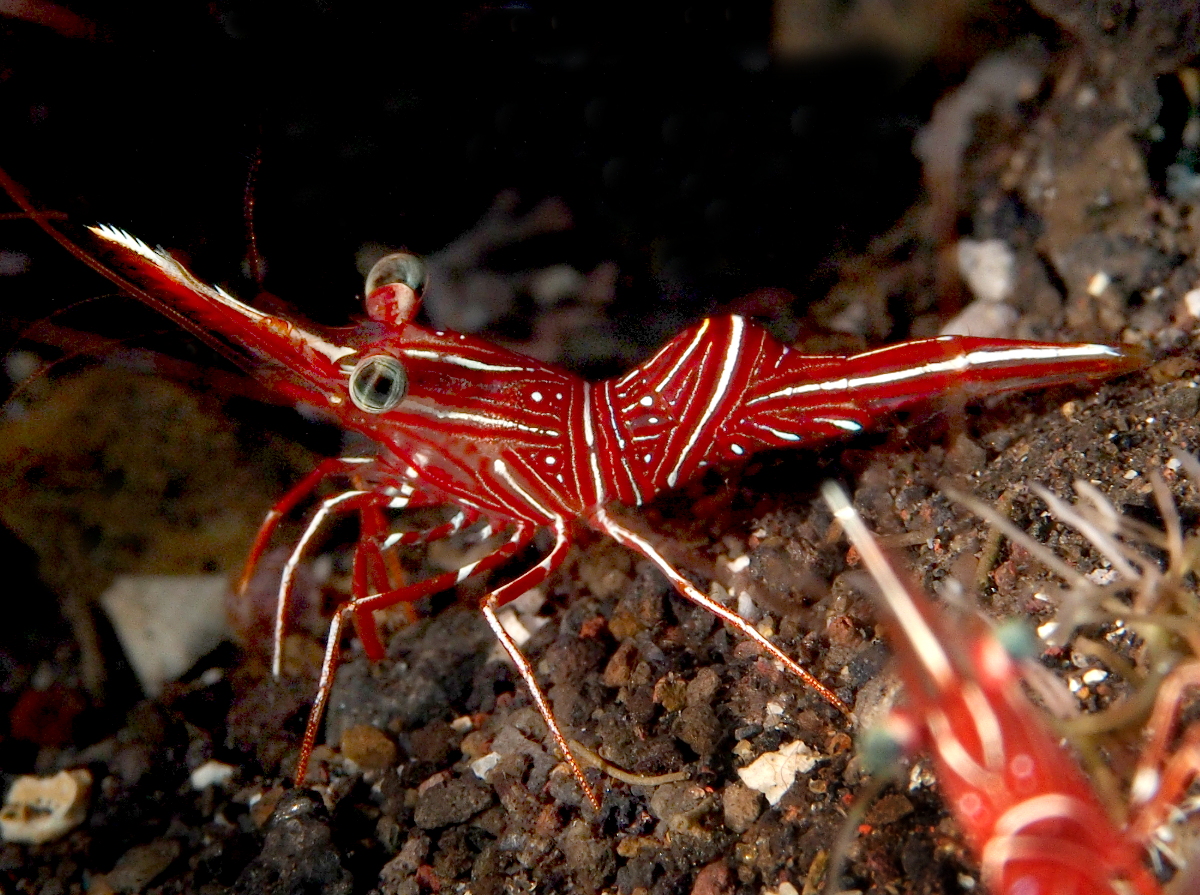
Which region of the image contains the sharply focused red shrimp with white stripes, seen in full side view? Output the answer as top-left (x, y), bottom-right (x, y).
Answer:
top-left (0, 161), bottom-right (1140, 804)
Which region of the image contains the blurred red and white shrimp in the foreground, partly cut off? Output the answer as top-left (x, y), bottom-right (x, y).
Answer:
top-left (823, 483), bottom-right (1160, 895)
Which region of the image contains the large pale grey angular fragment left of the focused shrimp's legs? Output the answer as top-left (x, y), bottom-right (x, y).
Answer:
top-left (100, 575), bottom-right (229, 696)
